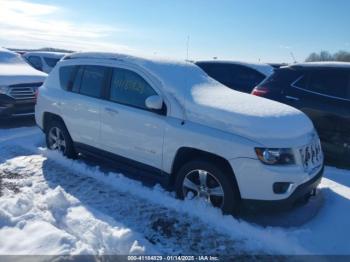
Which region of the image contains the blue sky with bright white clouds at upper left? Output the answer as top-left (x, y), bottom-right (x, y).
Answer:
top-left (0, 0), bottom-right (350, 62)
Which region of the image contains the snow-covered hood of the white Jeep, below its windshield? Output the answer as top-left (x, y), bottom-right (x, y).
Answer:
top-left (186, 85), bottom-right (314, 145)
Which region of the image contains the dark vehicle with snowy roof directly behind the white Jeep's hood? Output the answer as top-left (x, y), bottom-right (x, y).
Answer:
top-left (196, 60), bottom-right (274, 93)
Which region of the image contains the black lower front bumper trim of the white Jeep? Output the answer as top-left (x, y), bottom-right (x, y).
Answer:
top-left (242, 167), bottom-right (324, 211)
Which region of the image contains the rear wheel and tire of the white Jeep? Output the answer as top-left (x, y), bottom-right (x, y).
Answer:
top-left (45, 120), bottom-right (77, 159)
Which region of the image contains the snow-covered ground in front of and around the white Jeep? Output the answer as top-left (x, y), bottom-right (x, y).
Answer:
top-left (0, 124), bottom-right (350, 255)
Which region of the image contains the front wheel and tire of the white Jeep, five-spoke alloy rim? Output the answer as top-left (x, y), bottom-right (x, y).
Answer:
top-left (175, 160), bottom-right (240, 214)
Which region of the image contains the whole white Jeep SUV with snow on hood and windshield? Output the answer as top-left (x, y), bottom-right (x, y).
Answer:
top-left (35, 53), bottom-right (323, 212)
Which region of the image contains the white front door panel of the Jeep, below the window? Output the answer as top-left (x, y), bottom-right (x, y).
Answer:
top-left (100, 101), bottom-right (166, 169)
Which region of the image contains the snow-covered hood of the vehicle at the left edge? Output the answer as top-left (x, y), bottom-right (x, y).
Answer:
top-left (0, 62), bottom-right (47, 86)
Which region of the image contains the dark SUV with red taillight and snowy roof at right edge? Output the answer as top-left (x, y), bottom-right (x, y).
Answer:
top-left (252, 62), bottom-right (350, 166)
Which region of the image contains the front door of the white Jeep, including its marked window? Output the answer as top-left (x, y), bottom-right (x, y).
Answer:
top-left (101, 68), bottom-right (166, 169)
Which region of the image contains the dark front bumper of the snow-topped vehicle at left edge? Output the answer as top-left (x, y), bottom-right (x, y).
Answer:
top-left (0, 95), bottom-right (35, 117)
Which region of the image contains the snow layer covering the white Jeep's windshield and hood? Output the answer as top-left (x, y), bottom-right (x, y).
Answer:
top-left (138, 58), bottom-right (314, 140)
